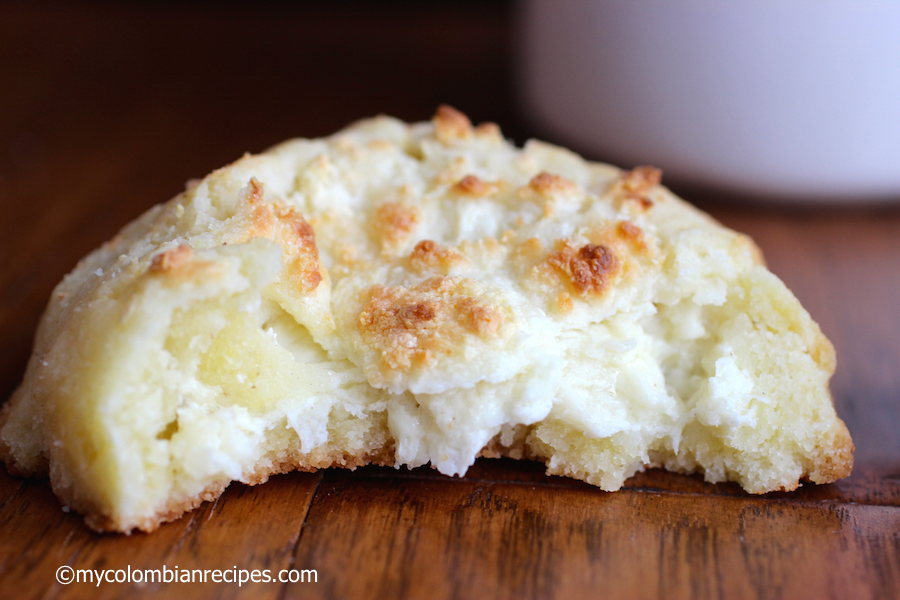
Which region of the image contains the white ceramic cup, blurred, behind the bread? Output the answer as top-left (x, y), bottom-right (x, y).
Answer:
top-left (519, 0), bottom-right (900, 202)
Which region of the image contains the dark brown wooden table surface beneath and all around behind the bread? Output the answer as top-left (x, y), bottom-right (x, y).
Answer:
top-left (0, 2), bottom-right (900, 599)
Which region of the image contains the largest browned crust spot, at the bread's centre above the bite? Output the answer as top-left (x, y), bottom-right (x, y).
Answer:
top-left (357, 277), bottom-right (503, 371)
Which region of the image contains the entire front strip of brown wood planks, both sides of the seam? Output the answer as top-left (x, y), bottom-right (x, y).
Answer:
top-left (0, 459), bottom-right (900, 598)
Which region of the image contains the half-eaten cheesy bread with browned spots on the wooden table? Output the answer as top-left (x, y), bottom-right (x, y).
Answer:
top-left (0, 107), bottom-right (853, 532)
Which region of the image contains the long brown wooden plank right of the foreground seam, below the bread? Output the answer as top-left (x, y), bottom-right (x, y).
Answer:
top-left (286, 473), bottom-right (900, 599)
